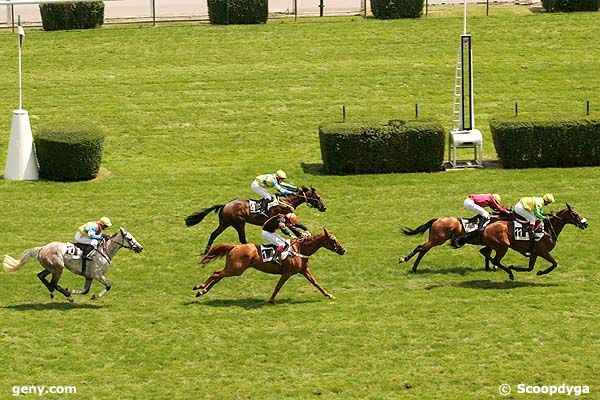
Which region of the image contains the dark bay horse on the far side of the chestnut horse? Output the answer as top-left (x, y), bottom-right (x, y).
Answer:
top-left (185, 187), bottom-right (327, 254)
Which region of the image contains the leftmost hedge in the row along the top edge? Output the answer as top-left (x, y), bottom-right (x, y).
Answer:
top-left (40, 1), bottom-right (104, 31)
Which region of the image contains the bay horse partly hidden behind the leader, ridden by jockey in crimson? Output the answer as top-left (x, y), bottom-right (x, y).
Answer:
top-left (398, 214), bottom-right (511, 272)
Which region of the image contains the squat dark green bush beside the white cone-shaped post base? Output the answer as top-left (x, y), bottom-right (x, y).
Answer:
top-left (34, 127), bottom-right (104, 181)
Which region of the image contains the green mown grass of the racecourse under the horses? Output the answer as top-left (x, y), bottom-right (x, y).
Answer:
top-left (0, 7), bottom-right (600, 399)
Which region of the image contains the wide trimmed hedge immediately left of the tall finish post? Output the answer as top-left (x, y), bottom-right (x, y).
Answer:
top-left (319, 120), bottom-right (445, 175)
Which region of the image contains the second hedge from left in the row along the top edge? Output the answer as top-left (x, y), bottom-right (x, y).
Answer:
top-left (208, 0), bottom-right (269, 25)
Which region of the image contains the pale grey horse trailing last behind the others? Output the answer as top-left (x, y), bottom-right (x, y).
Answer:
top-left (4, 228), bottom-right (144, 302)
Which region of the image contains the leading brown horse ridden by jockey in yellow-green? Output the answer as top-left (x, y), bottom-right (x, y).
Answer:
top-left (481, 204), bottom-right (588, 280)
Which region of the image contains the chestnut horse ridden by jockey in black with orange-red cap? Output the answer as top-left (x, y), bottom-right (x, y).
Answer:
top-left (193, 229), bottom-right (346, 303)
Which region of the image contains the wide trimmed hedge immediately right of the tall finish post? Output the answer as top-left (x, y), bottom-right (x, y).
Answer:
top-left (490, 117), bottom-right (600, 168)
